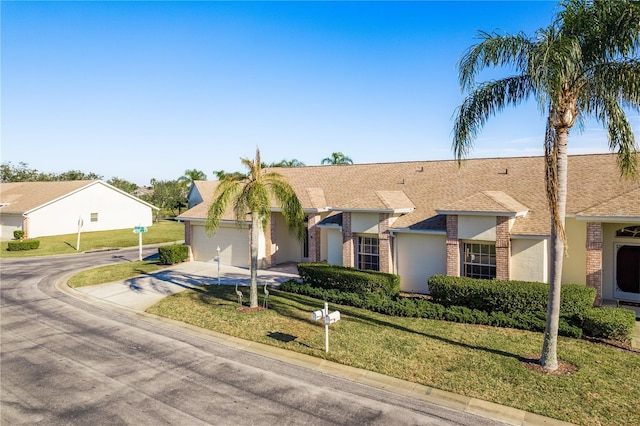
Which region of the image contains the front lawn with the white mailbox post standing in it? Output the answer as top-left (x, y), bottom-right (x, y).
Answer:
top-left (148, 286), bottom-right (640, 425)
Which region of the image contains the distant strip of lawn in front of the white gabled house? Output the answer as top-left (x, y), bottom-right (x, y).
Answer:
top-left (0, 220), bottom-right (184, 258)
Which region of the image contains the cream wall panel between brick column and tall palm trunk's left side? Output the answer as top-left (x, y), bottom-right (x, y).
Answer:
top-left (511, 238), bottom-right (549, 282)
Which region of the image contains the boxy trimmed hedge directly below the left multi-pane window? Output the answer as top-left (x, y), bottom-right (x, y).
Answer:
top-left (298, 263), bottom-right (400, 296)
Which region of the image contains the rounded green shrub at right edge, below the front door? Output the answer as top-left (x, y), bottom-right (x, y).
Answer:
top-left (582, 306), bottom-right (636, 342)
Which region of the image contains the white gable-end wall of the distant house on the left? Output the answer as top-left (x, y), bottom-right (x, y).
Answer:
top-left (28, 183), bottom-right (153, 238)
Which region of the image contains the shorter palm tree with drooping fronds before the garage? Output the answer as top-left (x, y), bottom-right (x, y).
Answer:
top-left (205, 149), bottom-right (304, 308)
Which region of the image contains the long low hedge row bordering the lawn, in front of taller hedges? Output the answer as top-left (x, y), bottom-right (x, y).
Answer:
top-left (280, 280), bottom-right (582, 339)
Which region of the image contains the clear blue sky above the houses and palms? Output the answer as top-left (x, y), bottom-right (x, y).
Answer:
top-left (0, 1), bottom-right (640, 185)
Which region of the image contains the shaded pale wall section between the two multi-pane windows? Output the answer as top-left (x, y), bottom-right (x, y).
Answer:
top-left (395, 233), bottom-right (447, 293)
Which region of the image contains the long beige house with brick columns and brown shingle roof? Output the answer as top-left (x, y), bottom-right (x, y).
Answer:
top-left (179, 154), bottom-right (640, 303)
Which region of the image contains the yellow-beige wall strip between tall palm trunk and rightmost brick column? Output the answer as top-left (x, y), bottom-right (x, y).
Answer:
top-left (562, 218), bottom-right (587, 285)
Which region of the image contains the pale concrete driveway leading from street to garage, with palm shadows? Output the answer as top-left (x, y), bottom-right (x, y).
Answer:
top-left (75, 261), bottom-right (299, 311)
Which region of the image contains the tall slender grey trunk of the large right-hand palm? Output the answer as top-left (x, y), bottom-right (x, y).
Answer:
top-left (540, 128), bottom-right (569, 371)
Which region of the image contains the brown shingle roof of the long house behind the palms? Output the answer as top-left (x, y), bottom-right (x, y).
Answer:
top-left (176, 154), bottom-right (640, 235)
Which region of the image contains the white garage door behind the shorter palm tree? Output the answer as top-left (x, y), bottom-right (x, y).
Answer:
top-left (191, 224), bottom-right (250, 268)
